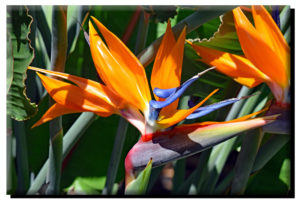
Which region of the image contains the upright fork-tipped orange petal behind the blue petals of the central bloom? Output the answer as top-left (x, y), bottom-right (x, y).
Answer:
top-left (151, 21), bottom-right (186, 116)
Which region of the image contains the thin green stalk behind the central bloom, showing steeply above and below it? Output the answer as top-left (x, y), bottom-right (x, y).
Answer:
top-left (102, 9), bottom-right (149, 195)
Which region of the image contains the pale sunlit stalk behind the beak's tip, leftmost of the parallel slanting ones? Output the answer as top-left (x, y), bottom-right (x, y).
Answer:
top-left (198, 86), bottom-right (251, 194)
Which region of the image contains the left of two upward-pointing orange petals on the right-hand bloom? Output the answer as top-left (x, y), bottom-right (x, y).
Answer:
top-left (233, 8), bottom-right (288, 87)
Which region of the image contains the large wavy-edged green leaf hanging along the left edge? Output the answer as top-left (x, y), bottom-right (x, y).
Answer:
top-left (7, 6), bottom-right (37, 121)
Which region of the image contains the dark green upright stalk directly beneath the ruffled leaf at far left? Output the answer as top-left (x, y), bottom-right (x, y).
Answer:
top-left (13, 120), bottom-right (30, 194)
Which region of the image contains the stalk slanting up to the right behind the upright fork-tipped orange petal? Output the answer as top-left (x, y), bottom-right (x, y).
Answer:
top-left (138, 6), bottom-right (234, 67)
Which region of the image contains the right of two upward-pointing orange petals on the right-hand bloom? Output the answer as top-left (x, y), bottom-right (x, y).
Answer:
top-left (252, 6), bottom-right (290, 79)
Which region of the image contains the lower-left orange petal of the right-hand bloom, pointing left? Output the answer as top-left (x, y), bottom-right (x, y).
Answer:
top-left (188, 41), bottom-right (270, 88)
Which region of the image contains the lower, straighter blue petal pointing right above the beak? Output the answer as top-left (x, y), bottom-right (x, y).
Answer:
top-left (186, 97), bottom-right (240, 119)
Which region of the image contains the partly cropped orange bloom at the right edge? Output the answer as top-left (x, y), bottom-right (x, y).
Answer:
top-left (189, 6), bottom-right (290, 105)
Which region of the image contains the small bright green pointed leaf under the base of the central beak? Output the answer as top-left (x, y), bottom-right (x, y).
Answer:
top-left (125, 159), bottom-right (152, 195)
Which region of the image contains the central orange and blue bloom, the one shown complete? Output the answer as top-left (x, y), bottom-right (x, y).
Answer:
top-left (28, 17), bottom-right (276, 184)
